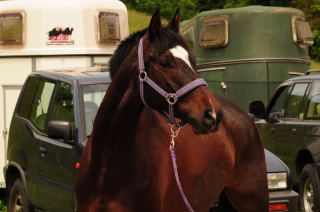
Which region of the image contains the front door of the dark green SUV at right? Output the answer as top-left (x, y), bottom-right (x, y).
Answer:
top-left (263, 82), bottom-right (309, 181)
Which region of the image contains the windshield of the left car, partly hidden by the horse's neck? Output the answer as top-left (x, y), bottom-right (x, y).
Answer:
top-left (82, 84), bottom-right (109, 136)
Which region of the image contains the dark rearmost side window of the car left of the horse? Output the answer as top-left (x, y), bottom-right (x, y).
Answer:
top-left (17, 77), bottom-right (39, 118)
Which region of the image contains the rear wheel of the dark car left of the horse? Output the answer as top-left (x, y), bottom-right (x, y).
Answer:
top-left (8, 178), bottom-right (31, 212)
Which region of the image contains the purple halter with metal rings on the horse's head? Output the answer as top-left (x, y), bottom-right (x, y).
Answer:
top-left (138, 38), bottom-right (208, 127)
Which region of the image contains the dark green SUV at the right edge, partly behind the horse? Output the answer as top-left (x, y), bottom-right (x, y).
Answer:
top-left (249, 72), bottom-right (320, 212)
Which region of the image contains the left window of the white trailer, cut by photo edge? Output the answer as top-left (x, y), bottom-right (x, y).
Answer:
top-left (0, 13), bottom-right (23, 45)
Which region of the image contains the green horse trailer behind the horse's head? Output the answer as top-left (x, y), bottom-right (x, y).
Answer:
top-left (180, 6), bottom-right (313, 110)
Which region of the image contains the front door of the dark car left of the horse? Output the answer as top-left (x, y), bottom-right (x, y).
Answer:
top-left (39, 82), bottom-right (80, 212)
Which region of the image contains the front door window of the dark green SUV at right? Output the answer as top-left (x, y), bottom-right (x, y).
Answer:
top-left (284, 83), bottom-right (309, 119)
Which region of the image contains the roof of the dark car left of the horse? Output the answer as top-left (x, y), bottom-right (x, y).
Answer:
top-left (30, 67), bottom-right (111, 84)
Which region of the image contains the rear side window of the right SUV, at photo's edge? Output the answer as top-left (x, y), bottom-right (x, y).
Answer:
top-left (306, 81), bottom-right (320, 119)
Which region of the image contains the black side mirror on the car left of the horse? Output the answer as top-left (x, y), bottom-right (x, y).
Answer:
top-left (48, 121), bottom-right (74, 144)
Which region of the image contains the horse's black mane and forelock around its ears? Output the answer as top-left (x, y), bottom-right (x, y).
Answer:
top-left (109, 27), bottom-right (189, 78)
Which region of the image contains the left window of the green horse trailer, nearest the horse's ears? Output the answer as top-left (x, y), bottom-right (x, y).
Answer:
top-left (200, 18), bottom-right (228, 48)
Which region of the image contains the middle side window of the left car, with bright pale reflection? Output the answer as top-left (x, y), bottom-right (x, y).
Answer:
top-left (30, 79), bottom-right (55, 132)
